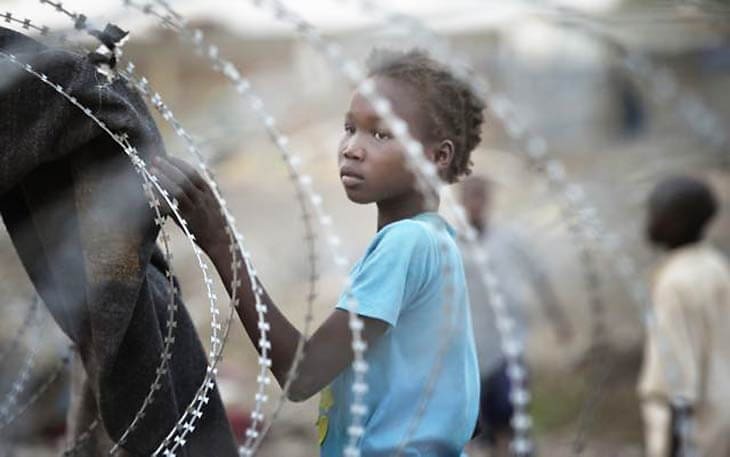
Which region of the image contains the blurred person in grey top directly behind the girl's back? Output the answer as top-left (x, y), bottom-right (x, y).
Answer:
top-left (461, 176), bottom-right (573, 456)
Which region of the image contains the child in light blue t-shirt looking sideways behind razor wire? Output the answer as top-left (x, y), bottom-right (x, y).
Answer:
top-left (156, 51), bottom-right (484, 457)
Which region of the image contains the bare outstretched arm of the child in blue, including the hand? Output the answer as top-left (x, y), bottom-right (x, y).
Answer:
top-left (153, 158), bottom-right (388, 401)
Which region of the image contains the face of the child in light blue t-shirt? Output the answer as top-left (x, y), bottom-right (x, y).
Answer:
top-left (337, 77), bottom-right (433, 203)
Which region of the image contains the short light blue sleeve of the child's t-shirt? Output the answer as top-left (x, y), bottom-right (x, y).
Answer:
top-left (337, 221), bottom-right (437, 326)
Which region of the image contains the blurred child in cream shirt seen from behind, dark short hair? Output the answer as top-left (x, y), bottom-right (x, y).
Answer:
top-left (638, 176), bottom-right (730, 457)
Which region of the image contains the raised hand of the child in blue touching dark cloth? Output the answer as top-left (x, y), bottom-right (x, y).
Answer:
top-left (151, 156), bottom-right (229, 255)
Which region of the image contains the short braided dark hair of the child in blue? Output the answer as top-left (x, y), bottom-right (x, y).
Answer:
top-left (367, 49), bottom-right (485, 183)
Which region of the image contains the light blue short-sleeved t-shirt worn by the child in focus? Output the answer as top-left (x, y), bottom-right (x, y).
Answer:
top-left (317, 213), bottom-right (479, 457)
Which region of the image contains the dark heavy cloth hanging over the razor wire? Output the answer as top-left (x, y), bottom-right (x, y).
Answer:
top-left (0, 28), bottom-right (237, 457)
